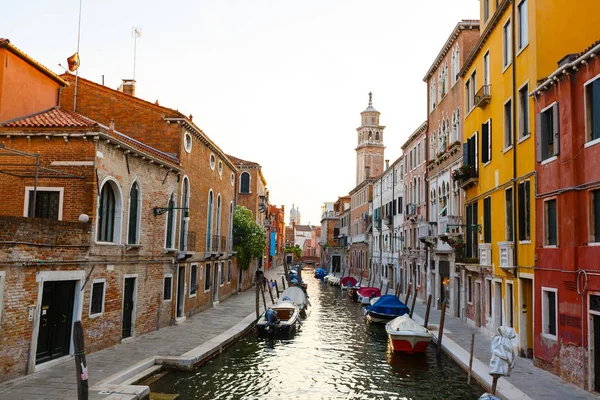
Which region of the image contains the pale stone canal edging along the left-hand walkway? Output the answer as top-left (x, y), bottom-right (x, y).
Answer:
top-left (90, 312), bottom-right (257, 400)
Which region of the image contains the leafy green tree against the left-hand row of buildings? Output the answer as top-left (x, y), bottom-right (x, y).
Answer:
top-left (233, 206), bottom-right (267, 270)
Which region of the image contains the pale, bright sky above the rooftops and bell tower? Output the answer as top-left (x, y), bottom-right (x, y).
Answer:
top-left (0, 0), bottom-right (479, 225)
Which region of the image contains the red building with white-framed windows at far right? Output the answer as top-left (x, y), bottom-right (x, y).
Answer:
top-left (534, 42), bottom-right (600, 391)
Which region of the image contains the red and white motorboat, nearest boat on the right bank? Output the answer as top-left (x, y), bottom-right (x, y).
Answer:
top-left (385, 315), bottom-right (433, 354)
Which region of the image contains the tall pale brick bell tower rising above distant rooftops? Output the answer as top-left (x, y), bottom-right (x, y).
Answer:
top-left (355, 93), bottom-right (385, 186)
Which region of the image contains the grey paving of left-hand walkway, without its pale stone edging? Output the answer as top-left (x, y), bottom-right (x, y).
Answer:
top-left (0, 267), bottom-right (283, 400)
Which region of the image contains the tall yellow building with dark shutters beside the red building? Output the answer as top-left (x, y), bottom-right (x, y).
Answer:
top-left (455, 0), bottom-right (600, 357)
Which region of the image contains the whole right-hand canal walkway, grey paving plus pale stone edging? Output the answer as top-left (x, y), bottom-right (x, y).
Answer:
top-left (413, 300), bottom-right (600, 400)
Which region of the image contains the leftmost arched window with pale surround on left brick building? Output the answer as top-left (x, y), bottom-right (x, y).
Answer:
top-left (97, 180), bottom-right (121, 243)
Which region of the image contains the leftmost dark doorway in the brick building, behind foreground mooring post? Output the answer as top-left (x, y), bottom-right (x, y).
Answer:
top-left (35, 281), bottom-right (76, 364)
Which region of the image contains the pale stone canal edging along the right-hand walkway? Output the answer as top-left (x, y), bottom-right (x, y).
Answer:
top-left (413, 313), bottom-right (532, 400)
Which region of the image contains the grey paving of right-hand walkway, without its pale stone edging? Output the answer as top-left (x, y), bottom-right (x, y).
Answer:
top-left (414, 301), bottom-right (599, 400)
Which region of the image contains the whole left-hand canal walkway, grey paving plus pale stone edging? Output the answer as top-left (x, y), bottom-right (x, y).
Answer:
top-left (0, 267), bottom-right (283, 400)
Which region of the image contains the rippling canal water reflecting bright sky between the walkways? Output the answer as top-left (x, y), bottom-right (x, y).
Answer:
top-left (150, 271), bottom-right (483, 400)
